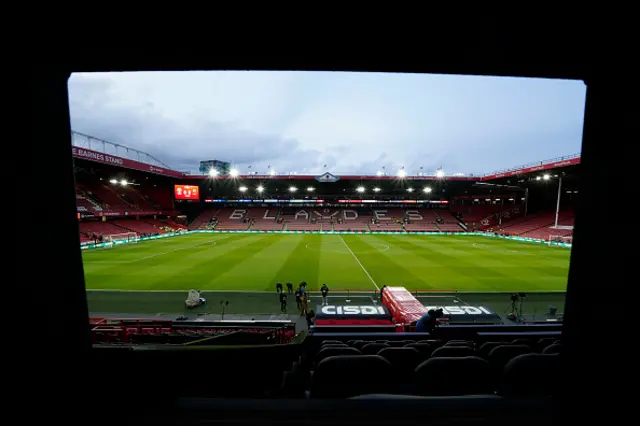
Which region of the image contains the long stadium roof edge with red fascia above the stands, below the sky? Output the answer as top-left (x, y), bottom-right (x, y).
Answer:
top-left (71, 131), bottom-right (580, 182)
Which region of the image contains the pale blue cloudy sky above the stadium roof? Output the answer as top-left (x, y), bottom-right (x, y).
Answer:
top-left (69, 71), bottom-right (586, 175)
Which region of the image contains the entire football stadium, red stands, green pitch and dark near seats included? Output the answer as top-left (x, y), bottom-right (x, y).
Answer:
top-left (72, 120), bottom-right (580, 398)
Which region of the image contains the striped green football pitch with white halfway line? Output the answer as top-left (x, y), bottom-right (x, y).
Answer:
top-left (83, 233), bottom-right (570, 313)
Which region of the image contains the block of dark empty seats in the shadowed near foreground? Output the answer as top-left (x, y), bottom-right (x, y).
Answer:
top-left (282, 334), bottom-right (561, 398)
